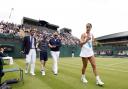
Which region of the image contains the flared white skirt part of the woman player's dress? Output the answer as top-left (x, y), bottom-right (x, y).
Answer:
top-left (80, 47), bottom-right (94, 57)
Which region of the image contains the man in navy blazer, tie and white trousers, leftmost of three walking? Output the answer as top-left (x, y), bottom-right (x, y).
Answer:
top-left (22, 29), bottom-right (36, 75)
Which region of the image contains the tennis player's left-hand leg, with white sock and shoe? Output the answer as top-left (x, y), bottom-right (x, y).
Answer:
top-left (81, 57), bottom-right (88, 83)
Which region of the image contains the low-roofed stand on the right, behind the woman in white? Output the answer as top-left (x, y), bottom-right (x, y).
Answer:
top-left (95, 31), bottom-right (128, 57)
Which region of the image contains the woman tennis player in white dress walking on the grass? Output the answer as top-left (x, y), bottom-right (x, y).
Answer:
top-left (80, 23), bottom-right (104, 85)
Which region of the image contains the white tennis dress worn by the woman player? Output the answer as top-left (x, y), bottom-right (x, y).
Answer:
top-left (80, 34), bottom-right (94, 57)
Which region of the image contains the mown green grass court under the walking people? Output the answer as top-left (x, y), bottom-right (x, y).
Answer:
top-left (2, 57), bottom-right (128, 89)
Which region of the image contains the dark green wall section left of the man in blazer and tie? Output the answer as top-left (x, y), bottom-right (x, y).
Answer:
top-left (0, 34), bottom-right (23, 57)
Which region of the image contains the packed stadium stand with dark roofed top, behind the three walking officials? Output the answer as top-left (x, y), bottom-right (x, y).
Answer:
top-left (0, 17), bottom-right (80, 57)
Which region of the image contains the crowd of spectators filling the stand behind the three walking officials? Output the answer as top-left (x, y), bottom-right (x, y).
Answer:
top-left (0, 21), bottom-right (79, 45)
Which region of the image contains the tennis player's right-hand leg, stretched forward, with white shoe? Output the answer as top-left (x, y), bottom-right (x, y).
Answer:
top-left (89, 56), bottom-right (104, 85)
